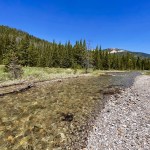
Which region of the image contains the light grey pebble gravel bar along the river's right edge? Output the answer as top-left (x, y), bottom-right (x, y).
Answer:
top-left (85, 75), bottom-right (150, 150)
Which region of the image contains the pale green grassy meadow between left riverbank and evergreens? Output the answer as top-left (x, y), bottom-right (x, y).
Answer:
top-left (0, 65), bottom-right (89, 83)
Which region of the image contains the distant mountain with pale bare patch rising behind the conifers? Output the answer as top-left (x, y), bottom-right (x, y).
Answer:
top-left (104, 48), bottom-right (150, 58)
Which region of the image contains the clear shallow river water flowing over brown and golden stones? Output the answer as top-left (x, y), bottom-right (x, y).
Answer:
top-left (0, 72), bottom-right (140, 150)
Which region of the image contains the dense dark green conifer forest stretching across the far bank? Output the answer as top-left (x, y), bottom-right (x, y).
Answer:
top-left (0, 26), bottom-right (150, 70)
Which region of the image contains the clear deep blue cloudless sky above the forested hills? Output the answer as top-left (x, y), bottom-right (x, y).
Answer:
top-left (0, 0), bottom-right (150, 53)
